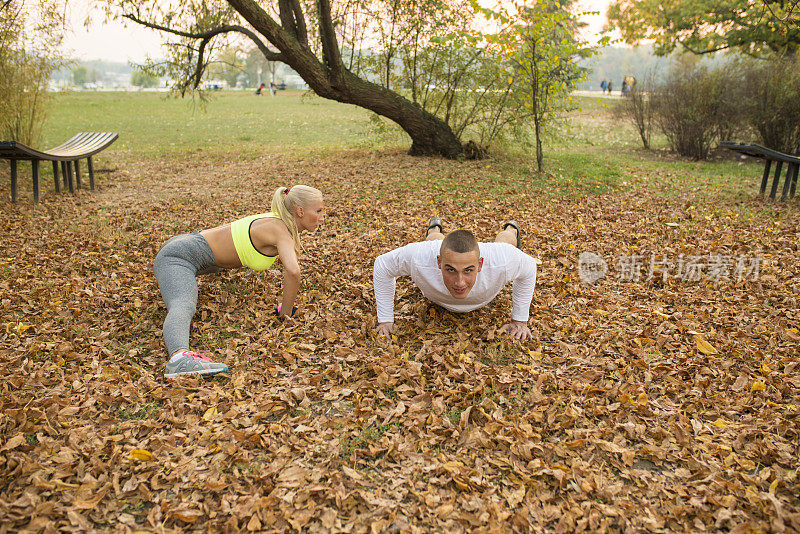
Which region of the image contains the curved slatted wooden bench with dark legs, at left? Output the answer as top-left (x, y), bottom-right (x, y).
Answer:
top-left (0, 132), bottom-right (119, 203)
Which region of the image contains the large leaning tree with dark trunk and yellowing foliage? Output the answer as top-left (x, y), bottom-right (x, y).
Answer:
top-left (105, 0), bottom-right (464, 158)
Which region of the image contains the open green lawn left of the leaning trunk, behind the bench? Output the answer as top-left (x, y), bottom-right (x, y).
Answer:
top-left (43, 91), bottom-right (400, 155)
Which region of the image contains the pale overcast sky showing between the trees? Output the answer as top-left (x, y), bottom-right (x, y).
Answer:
top-left (65, 0), bottom-right (611, 63)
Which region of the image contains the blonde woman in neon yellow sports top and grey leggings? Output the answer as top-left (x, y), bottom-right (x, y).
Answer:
top-left (153, 185), bottom-right (325, 378)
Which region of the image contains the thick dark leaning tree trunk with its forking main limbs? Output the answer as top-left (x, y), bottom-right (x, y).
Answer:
top-left (228, 0), bottom-right (463, 159)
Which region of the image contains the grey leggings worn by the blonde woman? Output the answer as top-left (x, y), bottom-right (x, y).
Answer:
top-left (153, 232), bottom-right (221, 355)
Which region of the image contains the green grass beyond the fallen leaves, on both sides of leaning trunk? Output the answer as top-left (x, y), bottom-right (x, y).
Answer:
top-left (36, 91), bottom-right (759, 201)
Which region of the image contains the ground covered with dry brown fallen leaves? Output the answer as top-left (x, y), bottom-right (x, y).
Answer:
top-left (0, 152), bottom-right (800, 532)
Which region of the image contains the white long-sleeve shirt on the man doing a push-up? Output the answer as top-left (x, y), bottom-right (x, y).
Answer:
top-left (372, 241), bottom-right (536, 323)
